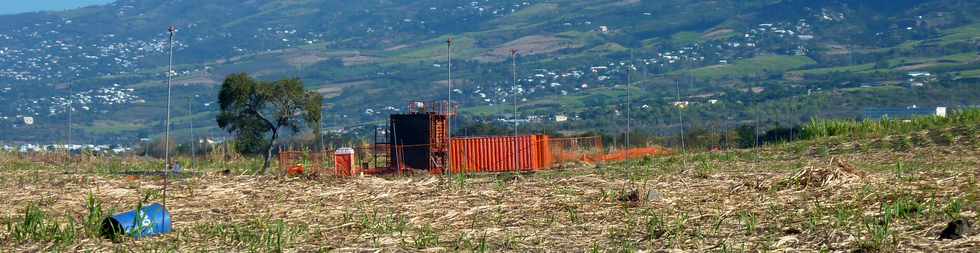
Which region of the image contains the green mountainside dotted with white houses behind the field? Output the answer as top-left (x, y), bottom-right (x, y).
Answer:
top-left (0, 0), bottom-right (980, 142)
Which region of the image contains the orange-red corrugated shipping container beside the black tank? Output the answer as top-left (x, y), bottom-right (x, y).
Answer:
top-left (452, 135), bottom-right (553, 173)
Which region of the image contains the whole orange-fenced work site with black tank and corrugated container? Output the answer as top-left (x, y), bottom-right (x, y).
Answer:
top-left (279, 102), bottom-right (670, 176)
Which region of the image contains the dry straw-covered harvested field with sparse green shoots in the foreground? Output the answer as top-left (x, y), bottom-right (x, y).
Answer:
top-left (0, 134), bottom-right (980, 252)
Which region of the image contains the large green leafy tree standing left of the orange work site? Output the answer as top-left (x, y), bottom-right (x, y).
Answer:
top-left (217, 73), bottom-right (323, 174)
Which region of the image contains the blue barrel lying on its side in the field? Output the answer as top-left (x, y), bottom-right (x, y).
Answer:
top-left (102, 204), bottom-right (173, 239)
